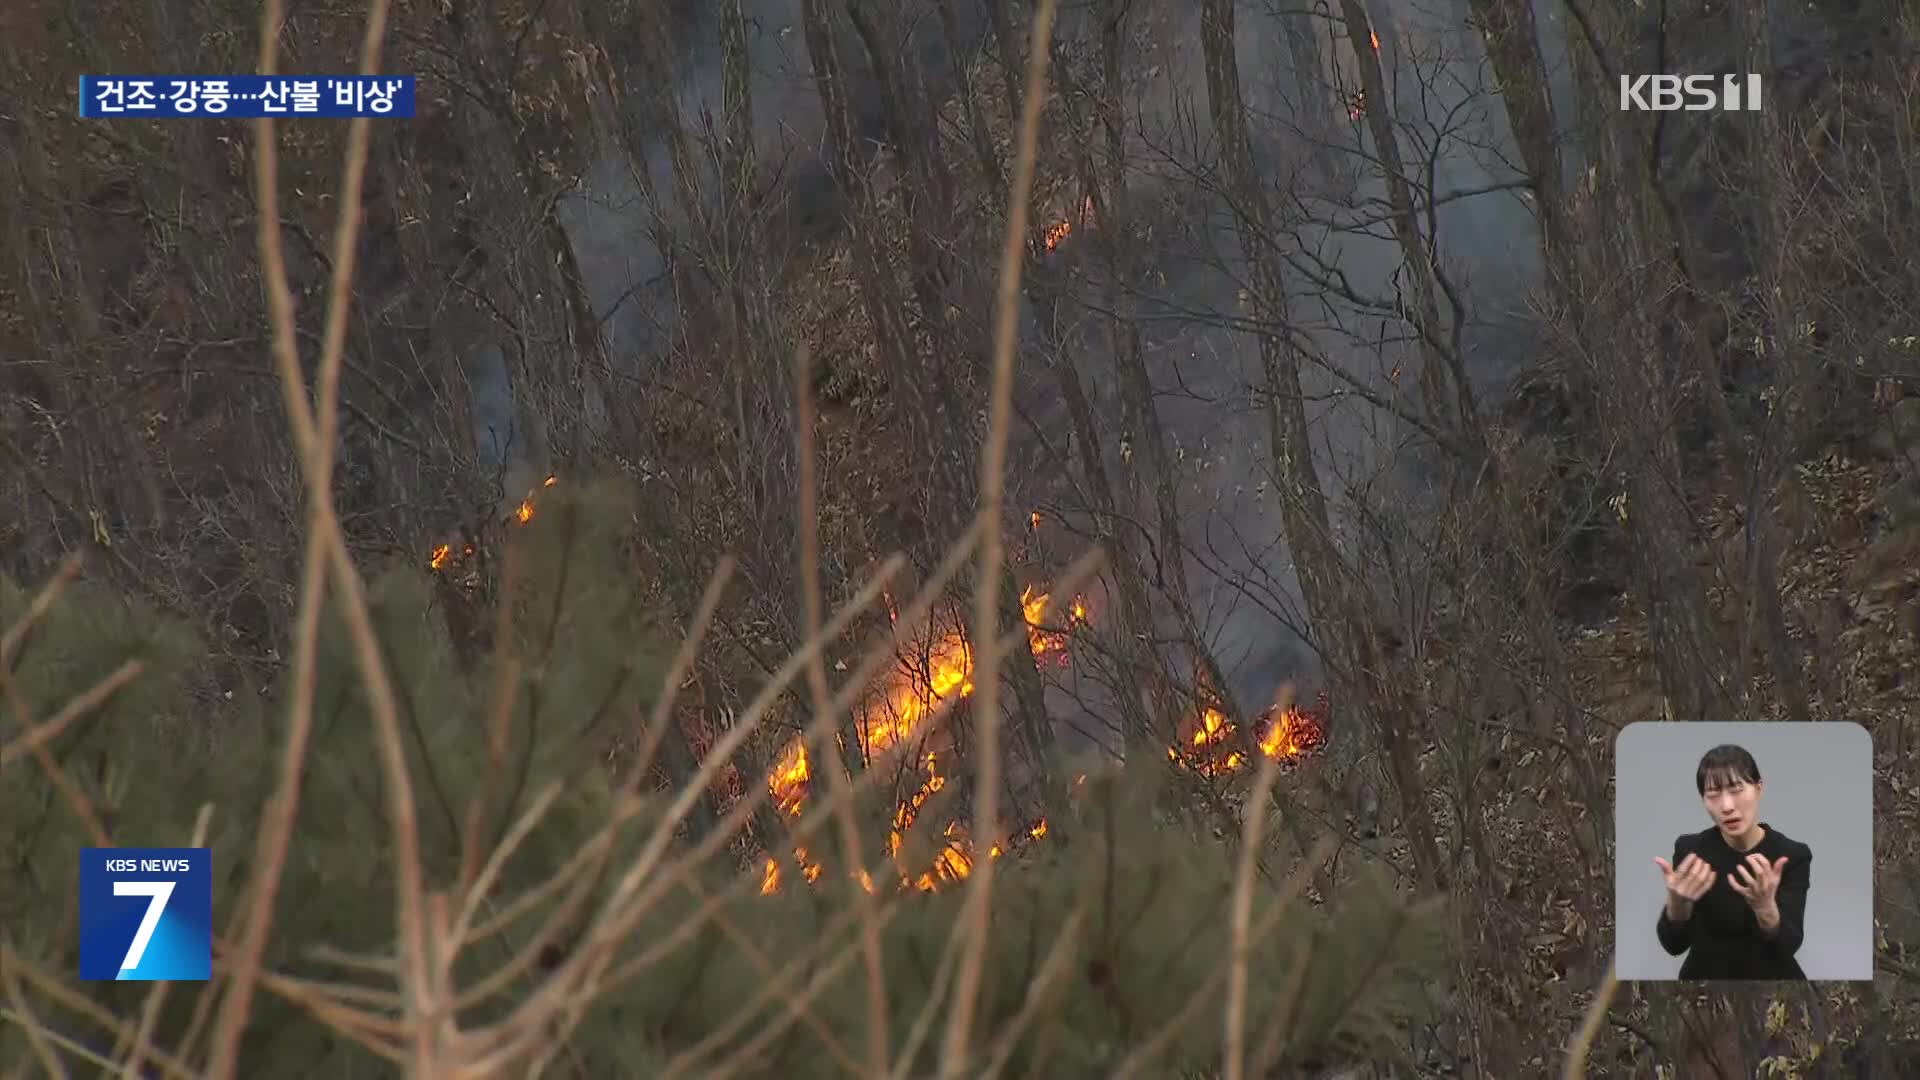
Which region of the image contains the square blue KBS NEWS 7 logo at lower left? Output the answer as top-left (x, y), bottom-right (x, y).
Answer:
top-left (81, 847), bottom-right (213, 982)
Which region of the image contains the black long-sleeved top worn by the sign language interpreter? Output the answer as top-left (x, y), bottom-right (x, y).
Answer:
top-left (1659, 822), bottom-right (1812, 978)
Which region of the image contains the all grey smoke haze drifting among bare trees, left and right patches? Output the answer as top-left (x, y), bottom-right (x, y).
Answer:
top-left (529, 0), bottom-right (1576, 737)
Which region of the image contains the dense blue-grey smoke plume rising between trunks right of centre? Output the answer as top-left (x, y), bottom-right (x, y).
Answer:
top-left (1044, 0), bottom-right (1569, 711)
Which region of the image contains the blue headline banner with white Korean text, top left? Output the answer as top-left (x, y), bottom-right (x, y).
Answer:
top-left (81, 75), bottom-right (415, 119)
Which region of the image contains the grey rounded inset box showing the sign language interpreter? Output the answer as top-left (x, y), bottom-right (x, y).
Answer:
top-left (1613, 723), bottom-right (1874, 980)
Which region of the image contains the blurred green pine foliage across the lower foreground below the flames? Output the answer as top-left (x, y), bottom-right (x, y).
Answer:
top-left (0, 488), bottom-right (1446, 1078)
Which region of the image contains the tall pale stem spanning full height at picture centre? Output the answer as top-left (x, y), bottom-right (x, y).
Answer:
top-left (941, 0), bottom-right (1054, 1076)
